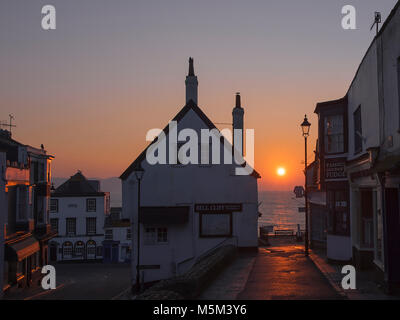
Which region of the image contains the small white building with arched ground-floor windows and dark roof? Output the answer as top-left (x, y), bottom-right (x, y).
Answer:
top-left (49, 171), bottom-right (110, 261)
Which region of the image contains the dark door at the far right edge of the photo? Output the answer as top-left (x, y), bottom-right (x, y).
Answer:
top-left (385, 188), bottom-right (400, 284)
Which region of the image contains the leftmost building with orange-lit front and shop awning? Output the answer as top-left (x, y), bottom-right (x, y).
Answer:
top-left (0, 130), bottom-right (55, 290)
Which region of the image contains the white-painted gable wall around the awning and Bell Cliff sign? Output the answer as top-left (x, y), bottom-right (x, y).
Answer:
top-left (121, 58), bottom-right (259, 283)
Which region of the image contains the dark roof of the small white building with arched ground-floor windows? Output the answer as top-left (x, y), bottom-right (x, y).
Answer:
top-left (51, 171), bottom-right (105, 197)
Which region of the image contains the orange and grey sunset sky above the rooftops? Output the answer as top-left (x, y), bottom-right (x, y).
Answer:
top-left (0, 0), bottom-right (396, 190)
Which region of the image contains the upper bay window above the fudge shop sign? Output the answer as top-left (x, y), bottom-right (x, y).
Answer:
top-left (325, 115), bottom-right (344, 153)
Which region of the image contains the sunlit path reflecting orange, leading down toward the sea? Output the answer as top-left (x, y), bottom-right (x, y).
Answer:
top-left (200, 237), bottom-right (344, 300)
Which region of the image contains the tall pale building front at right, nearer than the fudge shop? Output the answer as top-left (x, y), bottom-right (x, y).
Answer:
top-left (347, 3), bottom-right (400, 278)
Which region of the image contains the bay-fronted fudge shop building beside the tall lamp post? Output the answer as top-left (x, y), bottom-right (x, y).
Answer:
top-left (310, 98), bottom-right (352, 261)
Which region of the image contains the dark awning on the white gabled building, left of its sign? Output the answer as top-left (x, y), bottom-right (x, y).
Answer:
top-left (139, 207), bottom-right (190, 224)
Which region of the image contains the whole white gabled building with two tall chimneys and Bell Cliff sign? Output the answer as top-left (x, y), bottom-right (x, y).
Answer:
top-left (120, 59), bottom-right (260, 283)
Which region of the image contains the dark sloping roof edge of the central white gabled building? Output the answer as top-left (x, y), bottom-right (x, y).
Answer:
top-left (119, 100), bottom-right (261, 180)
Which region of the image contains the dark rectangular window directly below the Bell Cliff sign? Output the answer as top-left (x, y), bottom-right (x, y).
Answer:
top-left (200, 213), bottom-right (232, 237)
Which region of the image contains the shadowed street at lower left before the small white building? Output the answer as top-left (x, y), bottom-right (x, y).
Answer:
top-left (6, 263), bottom-right (130, 300)
